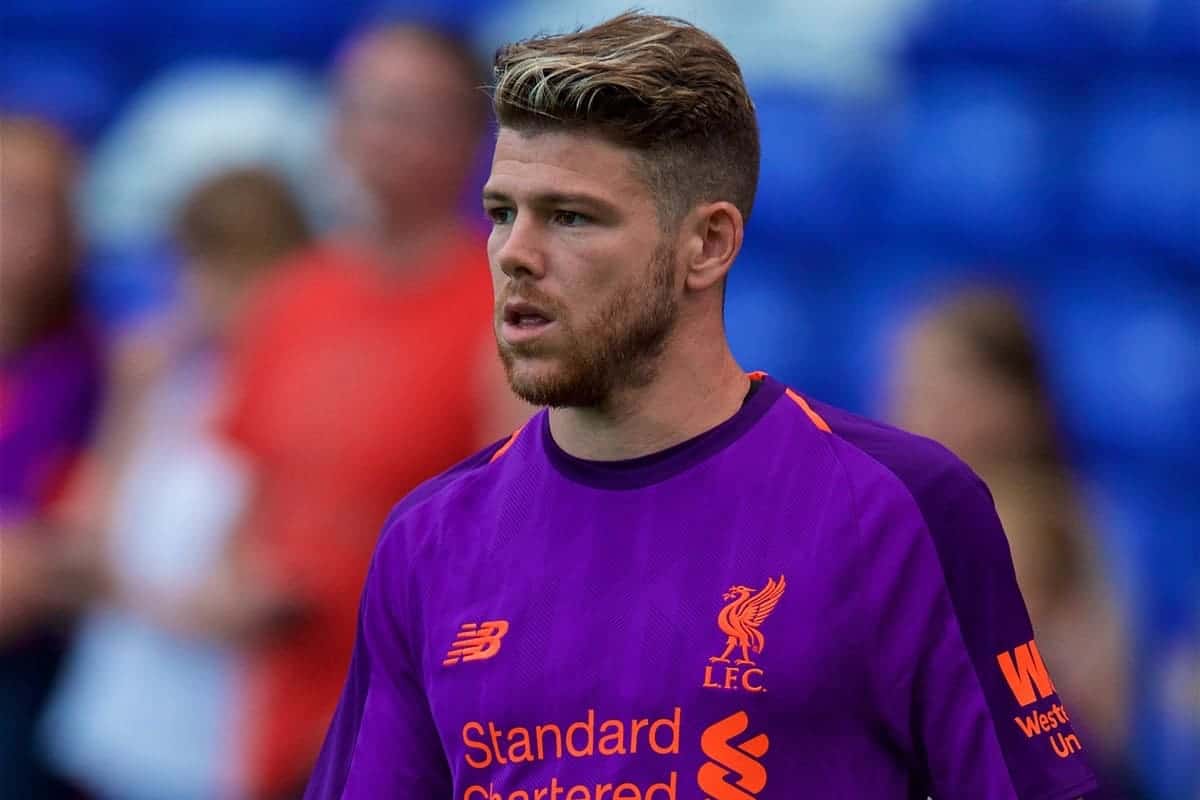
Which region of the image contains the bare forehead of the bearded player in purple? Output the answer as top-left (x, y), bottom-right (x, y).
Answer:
top-left (486, 128), bottom-right (653, 206)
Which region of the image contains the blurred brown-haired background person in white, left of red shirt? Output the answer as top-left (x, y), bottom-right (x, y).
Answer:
top-left (42, 169), bottom-right (308, 800)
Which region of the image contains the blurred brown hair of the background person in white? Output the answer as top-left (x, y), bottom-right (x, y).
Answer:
top-left (175, 168), bottom-right (310, 276)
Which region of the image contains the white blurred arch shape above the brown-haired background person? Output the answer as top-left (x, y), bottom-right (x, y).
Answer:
top-left (80, 62), bottom-right (331, 252)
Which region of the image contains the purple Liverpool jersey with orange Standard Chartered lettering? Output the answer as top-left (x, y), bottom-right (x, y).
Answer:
top-left (307, 375), bottom-right (1096, 800)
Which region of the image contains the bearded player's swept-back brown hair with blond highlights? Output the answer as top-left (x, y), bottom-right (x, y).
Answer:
top-left (493, 12), bottom-right (758, 227)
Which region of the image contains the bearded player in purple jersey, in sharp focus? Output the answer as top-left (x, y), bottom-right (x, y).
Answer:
top-left (308, 14), bottom-right (1094, 800)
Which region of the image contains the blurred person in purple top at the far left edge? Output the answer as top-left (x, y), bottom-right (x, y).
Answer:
top-left (0, 116), bottom-right (103, 799)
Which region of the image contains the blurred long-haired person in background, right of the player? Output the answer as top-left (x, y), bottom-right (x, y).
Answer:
top-left (890, 288), bottom-right (1133, 798)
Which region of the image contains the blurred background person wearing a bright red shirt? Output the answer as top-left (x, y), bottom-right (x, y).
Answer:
top-left (213, 18), bottom-right (529, 799)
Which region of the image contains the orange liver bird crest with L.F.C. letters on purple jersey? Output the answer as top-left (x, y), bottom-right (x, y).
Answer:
top-left (703, 576), bottom-right (787, 692)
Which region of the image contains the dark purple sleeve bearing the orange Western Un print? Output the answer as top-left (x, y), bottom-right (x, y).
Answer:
top-left (883, 465), bottom-right (1097, 800)
